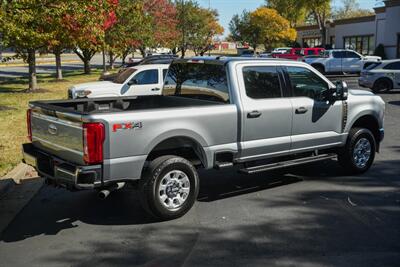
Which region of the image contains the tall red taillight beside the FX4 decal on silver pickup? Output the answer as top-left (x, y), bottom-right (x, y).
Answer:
top-left (83, 122), bottom-right (104, 164)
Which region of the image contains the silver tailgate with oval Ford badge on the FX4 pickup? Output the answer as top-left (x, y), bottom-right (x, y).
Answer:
top-left (31, 109), bottom-right (84, 164)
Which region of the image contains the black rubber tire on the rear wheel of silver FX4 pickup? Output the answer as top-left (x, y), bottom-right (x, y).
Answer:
top-left (139, 155), bottom-right (199, 220)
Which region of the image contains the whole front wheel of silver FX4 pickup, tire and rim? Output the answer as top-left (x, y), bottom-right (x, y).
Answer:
top-left (338, 128), bottom-right (376, 174)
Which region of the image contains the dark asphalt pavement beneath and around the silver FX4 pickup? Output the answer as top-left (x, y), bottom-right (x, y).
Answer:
top-left (0, 77), bottom-right (400, 267)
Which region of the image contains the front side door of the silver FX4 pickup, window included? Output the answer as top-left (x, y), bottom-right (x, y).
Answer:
top-left (286, 66), bottom-right (342, 152)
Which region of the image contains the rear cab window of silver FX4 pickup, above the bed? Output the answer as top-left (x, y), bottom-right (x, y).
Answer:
top-left (163, 63), bottom-right (229, 103)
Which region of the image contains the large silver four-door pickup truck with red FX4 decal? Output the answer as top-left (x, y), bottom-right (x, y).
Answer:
top-left (23, 57), bottom-right (385, 219)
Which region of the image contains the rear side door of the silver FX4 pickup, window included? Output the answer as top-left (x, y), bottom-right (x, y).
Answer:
top-left (237, 62), bottom-right (292, 160)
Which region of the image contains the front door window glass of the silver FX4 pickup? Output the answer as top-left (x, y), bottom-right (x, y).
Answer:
top-left (286, 67), bottom-right (329, 99)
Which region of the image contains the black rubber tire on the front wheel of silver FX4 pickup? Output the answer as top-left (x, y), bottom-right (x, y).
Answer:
top-left (338, 128), bottom-right (376, 174)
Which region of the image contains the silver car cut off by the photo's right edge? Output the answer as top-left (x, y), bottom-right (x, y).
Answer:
top-left (358, 59), bottom-right (400, 93)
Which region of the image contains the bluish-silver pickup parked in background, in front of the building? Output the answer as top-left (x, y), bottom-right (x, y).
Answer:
top-left (304, 49), bottom-right (381, 73)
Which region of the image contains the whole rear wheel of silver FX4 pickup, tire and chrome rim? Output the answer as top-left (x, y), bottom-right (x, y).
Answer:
top-left (139, 155), bottom-right (199, 220)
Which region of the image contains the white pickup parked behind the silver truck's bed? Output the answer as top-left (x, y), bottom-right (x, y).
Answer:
top-left (68, 64), bottom-right (169, 99)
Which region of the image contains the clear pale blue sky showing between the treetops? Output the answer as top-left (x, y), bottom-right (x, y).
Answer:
top-left (197, 0), bottom-right (380, 36)
